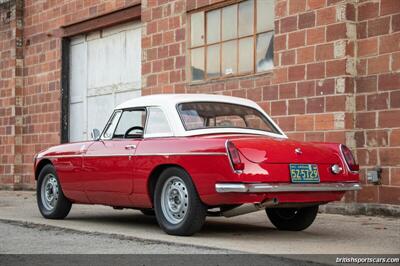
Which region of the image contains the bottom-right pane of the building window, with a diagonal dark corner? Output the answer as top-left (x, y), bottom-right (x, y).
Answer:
top-left (257, 31), bottom-right (274, 72)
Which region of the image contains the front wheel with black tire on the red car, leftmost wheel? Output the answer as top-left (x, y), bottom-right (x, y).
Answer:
top-left (36, 164), bottom-right (72, 219)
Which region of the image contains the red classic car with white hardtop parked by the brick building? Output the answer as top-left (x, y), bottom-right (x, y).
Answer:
top-left (35, 94), bottom-right (360, 235)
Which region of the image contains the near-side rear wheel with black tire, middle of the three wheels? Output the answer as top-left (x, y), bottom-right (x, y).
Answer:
top-left (154, 167), bottom-right (207, 236)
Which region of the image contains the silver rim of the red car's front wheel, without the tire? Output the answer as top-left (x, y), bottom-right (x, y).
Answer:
top-left (40, 174), bottom-right (59, 211)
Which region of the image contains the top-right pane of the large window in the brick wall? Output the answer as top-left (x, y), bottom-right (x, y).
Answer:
top-left (257, 0), bottom-right (275, 32)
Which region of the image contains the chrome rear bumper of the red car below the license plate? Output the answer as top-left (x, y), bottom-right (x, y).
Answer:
top-left (215, 183), bottom-right (361, 193)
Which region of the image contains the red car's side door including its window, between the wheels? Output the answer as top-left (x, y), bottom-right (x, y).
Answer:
top-left (83, 109), bottom-right (146, 206)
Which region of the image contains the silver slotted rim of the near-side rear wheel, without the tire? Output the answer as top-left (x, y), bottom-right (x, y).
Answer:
top-left (161, 176), bottom-right (189, 224)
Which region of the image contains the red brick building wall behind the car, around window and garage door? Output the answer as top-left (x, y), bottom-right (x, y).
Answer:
top-left (0, 0), bottom-right (400, 204)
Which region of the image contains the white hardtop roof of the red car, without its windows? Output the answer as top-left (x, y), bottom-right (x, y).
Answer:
top-left (115, 94), bottom-right (287, 138)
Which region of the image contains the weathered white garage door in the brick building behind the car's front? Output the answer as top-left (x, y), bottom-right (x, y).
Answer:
top-left (69, 22), bottom-right (141, 141)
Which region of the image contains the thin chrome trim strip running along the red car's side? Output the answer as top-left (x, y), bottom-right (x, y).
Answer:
top-left (43, 152), bottom-right (227, 158)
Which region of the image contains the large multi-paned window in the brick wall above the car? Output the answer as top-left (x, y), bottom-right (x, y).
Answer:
top-left (190, 0), bottom-right (275, 81)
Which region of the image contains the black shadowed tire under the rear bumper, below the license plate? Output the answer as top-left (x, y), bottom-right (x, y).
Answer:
top-left (265, 205), bottom-right (318, 231)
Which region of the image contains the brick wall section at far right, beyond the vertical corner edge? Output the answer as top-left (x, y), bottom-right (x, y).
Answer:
top-left (355, 0), bottom-right (400, 204)
